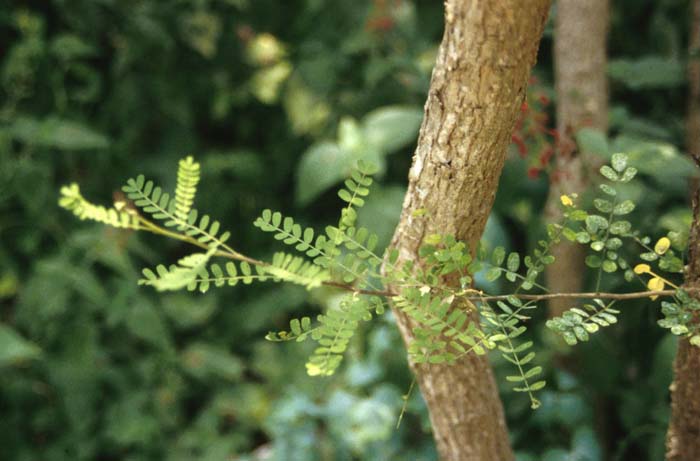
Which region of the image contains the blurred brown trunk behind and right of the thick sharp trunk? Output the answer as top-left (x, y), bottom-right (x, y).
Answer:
top-left (545, 0), bottom-right (608, 316)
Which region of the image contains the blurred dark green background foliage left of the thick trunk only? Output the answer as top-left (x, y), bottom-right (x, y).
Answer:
top-left (0, 0), bottom-right (442, 461)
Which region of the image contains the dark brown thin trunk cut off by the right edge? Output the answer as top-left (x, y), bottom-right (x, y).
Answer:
top-left (666, 0), bottom-right (700, 461)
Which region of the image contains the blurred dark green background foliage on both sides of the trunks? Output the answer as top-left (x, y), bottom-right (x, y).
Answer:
top-left (0, 0), bottom-right (690, 461)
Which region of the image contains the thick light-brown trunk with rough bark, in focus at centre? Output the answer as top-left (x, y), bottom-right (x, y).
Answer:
top-left (382, 0), bottom-right (549, 461)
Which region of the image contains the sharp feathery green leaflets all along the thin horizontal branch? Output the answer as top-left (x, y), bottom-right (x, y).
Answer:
top-left (61, 148), bottom-right (697, 420)
